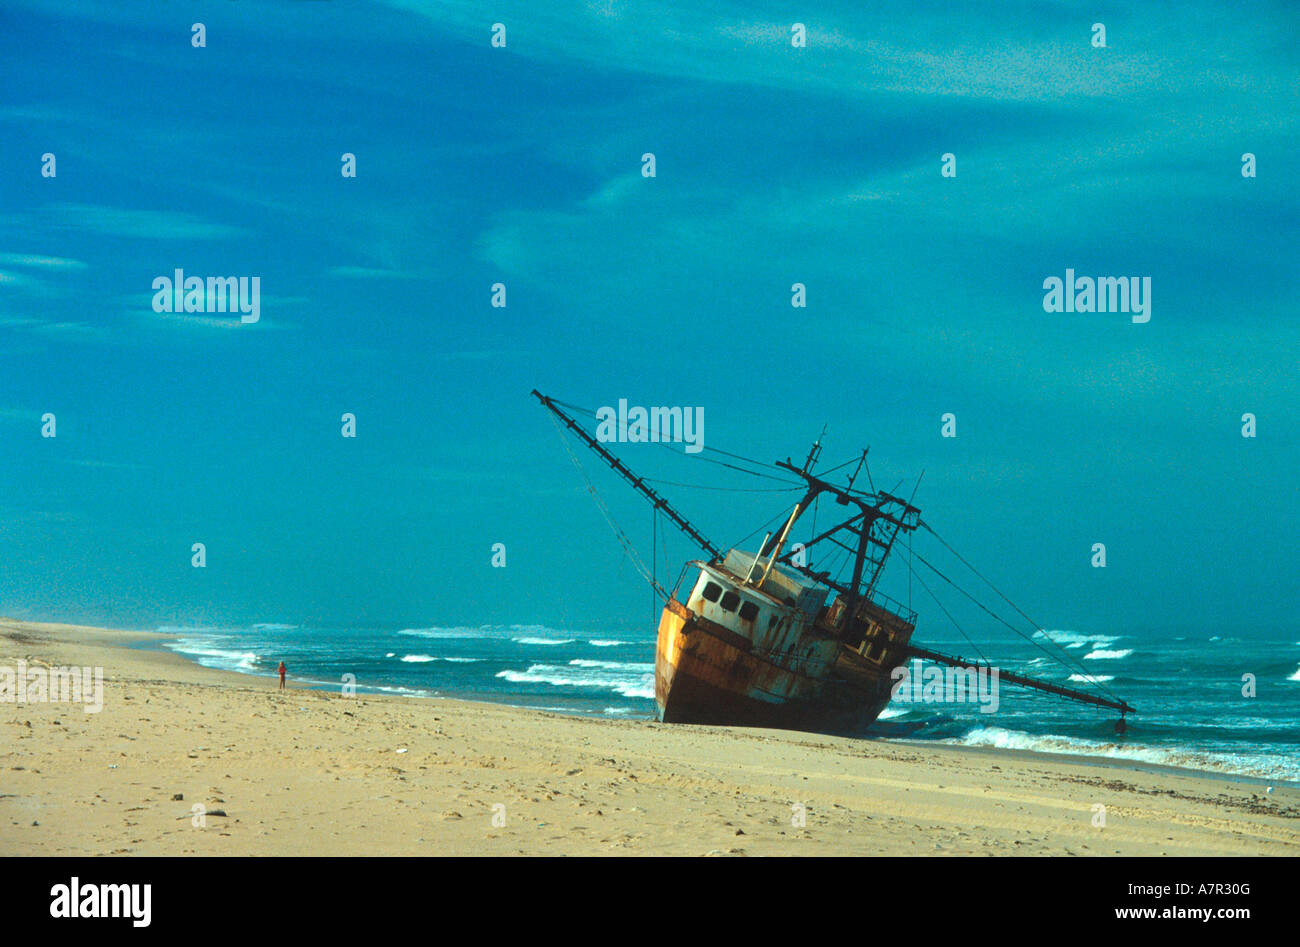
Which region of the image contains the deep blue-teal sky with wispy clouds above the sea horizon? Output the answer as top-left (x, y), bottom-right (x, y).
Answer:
top-left (0, 0), bottom-right (1300, 640)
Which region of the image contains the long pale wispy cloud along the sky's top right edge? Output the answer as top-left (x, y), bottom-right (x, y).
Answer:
top-left (387, 0), bottom-right (1295, 101)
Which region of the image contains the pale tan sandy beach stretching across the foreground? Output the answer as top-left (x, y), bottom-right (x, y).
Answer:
top-left (0, 619), bottom-right (1300, 856)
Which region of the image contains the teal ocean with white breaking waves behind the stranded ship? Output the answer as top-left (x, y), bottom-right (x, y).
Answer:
top-left (159, 623), bottom-right (1300, 783)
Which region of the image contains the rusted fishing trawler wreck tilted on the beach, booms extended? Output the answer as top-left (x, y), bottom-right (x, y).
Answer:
top-left (533, 390), bottom-right (1134, 732)
